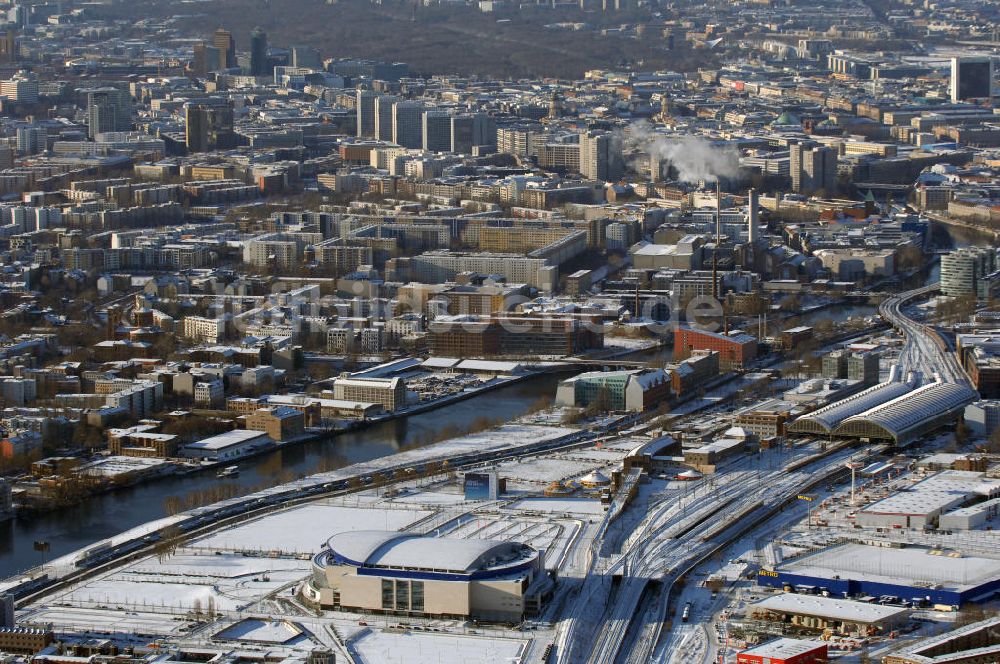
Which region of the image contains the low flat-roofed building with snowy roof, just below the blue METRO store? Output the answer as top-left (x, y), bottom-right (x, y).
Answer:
top-left (748, 593), bottom-right (910, 636)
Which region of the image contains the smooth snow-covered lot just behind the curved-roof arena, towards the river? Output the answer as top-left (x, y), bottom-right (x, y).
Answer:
top-left (193, 506), bottom-right (431, 554)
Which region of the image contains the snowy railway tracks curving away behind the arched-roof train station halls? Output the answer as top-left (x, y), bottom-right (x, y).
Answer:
top-left (879, 283), bottom-right (971, 386)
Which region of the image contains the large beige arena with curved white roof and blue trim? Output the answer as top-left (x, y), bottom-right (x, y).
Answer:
top-left (300, 530), bottom-right (553, 622)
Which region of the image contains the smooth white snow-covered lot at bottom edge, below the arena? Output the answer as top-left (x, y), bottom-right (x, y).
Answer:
top-left (353, 632), bottom-right (525, 664)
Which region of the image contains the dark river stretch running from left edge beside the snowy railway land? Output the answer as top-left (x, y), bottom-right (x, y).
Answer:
top-left (0, 374), bottom-right (563, 578)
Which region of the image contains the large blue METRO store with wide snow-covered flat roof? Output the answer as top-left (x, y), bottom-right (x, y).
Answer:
top-left (757, 544), bottom-right (1000, 606)
